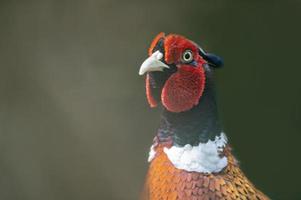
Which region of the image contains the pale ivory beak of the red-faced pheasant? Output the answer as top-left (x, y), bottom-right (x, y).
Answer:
top-left (139, 50), bottom-right (169, 75)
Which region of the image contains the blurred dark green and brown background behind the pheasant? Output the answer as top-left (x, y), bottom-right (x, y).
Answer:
top-left (0, 0), bottom-right (301, 200)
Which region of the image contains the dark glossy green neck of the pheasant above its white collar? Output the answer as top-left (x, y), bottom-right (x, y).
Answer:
top-left (158, 74), bottom-right (222, 146)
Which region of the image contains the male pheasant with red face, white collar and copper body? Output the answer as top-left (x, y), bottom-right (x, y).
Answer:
top-left (139, 33), bottom-right (269, 200)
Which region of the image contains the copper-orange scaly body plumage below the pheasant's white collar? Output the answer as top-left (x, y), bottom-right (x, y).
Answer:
top-left (142, 139), bottom-right (269, 200)
